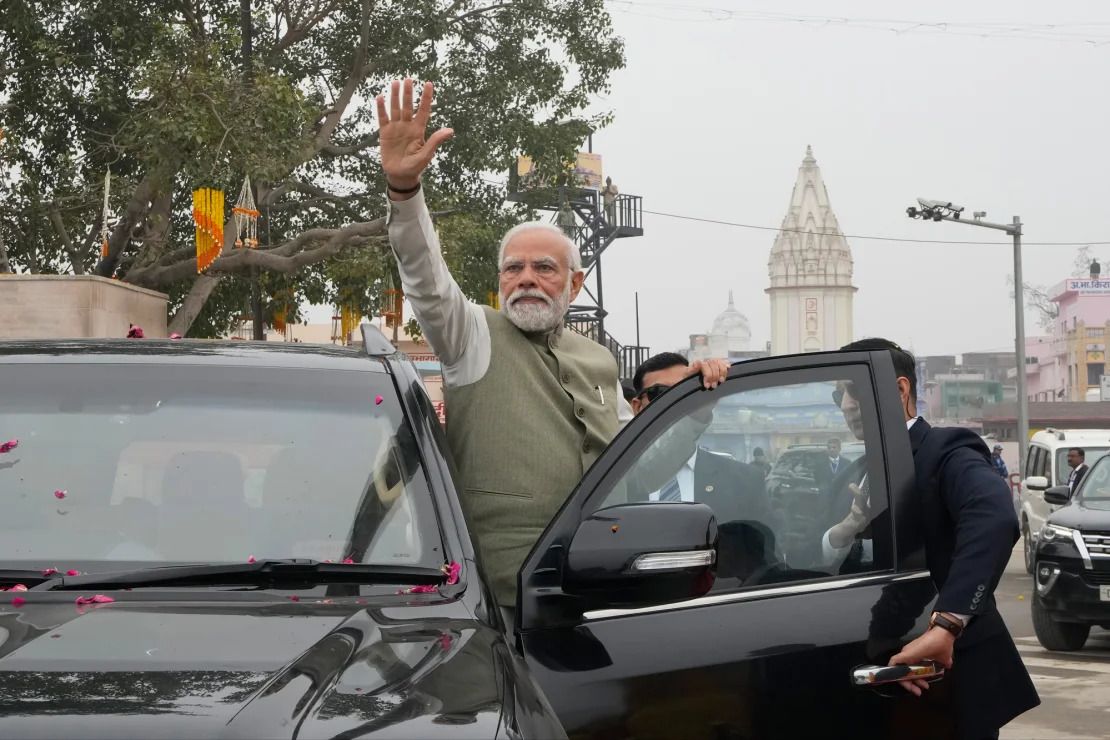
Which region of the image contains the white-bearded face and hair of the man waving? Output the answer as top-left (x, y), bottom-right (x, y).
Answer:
top-left (500, 230), bottom-right (585, 332)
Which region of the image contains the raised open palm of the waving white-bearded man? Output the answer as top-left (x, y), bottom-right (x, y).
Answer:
top-left (377, 78), bottom-right (455, 190)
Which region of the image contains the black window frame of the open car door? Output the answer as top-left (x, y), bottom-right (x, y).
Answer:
top-left (517, 352), bottom-right (925, 629)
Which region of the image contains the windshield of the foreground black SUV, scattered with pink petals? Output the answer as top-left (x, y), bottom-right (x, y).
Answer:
top-left (0, 363), bottom-right (443, 571)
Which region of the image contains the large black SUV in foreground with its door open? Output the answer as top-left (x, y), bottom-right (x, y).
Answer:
top-left (0, 327), bottom-right (967, 740)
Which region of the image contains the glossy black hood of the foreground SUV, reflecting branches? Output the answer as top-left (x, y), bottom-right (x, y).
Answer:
top-left (0, 591), bottom-right (505, 739)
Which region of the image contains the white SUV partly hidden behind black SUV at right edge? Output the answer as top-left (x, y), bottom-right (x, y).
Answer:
top-left (1018, 429), bottom-right (1110, 574)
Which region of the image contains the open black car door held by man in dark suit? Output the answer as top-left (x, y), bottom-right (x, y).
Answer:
top-left (517, 352), bottom-right (952, 740)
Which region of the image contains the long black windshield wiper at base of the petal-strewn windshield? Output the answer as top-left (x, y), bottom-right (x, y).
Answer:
top-left (31, 558), bottom-right (443, 591)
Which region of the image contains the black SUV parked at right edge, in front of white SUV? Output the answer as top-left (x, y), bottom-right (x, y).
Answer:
top-left (1031, 457), bottom-right (1110, 650)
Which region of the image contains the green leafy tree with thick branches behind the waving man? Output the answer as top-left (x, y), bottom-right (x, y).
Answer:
top-left (0, 0), bottom-right (624, 336)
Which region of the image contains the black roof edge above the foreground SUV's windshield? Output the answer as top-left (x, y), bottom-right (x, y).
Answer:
top-left (0, 339), bottom-right (390, 373)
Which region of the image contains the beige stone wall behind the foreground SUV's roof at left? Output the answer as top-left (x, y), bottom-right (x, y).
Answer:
top-left (0, 275), bottom-right (168, 339)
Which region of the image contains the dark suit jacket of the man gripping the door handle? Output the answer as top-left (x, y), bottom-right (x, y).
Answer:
top-left (909, 419), bottom-right (1040, 738)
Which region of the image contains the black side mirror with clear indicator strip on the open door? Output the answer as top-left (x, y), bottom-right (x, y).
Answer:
top-left (563, 503), bottom-right (717, 609)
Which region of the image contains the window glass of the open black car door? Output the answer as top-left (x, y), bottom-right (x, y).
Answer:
top-left (596, 367), bottom-right (905, 591)
